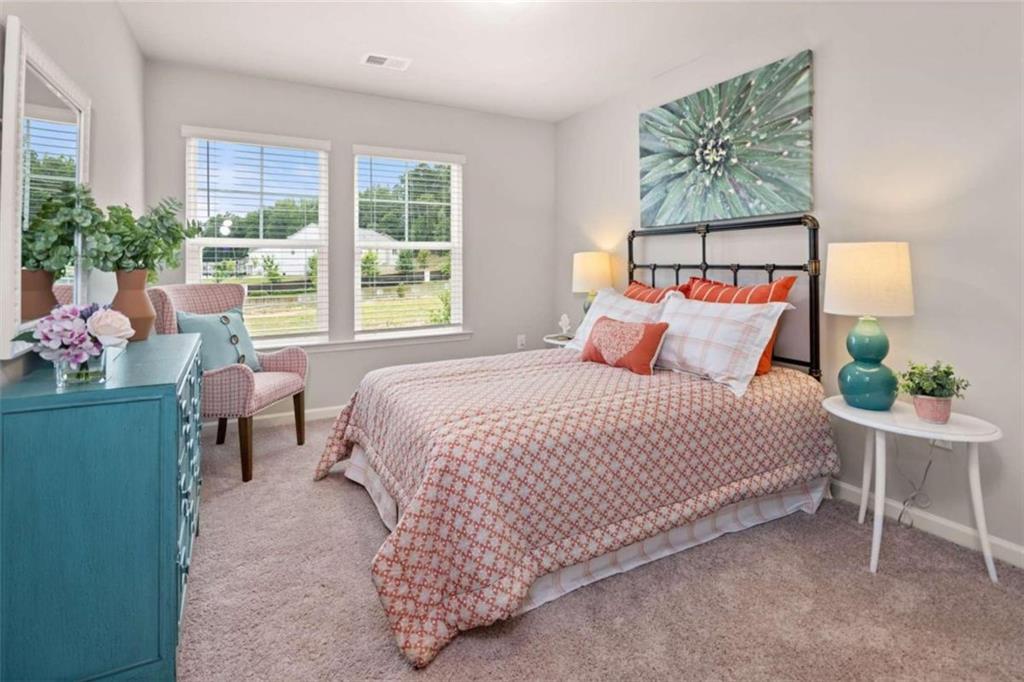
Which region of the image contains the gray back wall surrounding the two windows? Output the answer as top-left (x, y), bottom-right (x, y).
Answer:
top-left (145, 62), bottom-right (556, 414)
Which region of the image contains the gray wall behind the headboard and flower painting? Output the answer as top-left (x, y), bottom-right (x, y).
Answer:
top-left (554, 3), bottom-right (1024, 557)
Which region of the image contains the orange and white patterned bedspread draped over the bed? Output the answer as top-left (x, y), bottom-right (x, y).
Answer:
top-left (316, 349), bottom-right (839, 667)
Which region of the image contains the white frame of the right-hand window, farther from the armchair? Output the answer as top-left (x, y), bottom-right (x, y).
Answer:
top-left (352, 144), bottom-right (466, 340)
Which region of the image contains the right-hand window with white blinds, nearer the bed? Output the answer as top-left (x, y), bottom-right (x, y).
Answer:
top-left (354, 146), bottom-right (463, 334)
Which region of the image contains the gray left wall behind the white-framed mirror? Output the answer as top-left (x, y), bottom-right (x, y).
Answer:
top-left (0, 2), bottom-right (145, 383)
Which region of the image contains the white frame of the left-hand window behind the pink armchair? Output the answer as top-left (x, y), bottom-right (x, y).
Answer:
top-left (181, 125), bottom-right (331, 345)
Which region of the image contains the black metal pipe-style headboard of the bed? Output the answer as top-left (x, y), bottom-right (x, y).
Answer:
top-left (628, 214), bottom-right (821, 380)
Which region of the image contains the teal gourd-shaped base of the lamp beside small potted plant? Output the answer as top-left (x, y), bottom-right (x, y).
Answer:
top-left (839, 315), bottom-right (897, 411)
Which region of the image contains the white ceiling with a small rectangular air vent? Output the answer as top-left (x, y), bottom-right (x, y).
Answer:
top-left (120, 1), bottom-right (745, 121)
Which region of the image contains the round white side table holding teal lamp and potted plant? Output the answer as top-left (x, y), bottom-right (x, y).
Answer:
top-left (822, 395), bottom-right (1002, 583)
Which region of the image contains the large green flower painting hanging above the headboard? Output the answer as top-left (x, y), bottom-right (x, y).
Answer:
top-left (640, 50), bottom-right (812, 227)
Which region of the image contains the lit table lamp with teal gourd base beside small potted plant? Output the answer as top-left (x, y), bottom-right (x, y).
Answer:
top-left (824, 242), bottom-right (913, 411)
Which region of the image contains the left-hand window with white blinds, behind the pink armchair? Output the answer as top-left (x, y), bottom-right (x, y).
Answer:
top-left (182, 127), bottom-right (330, 337)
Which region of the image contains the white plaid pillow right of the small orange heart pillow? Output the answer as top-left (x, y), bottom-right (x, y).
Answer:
top-left (656, 292), bottom-right (793, 397)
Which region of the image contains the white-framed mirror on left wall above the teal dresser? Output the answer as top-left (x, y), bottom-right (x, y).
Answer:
top-left (0, 16), bottom-right (92, 359)
